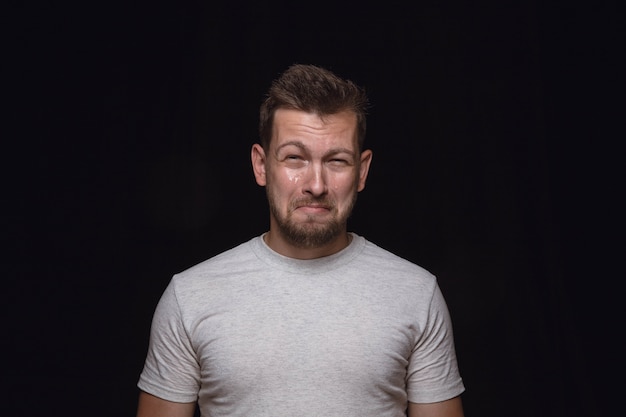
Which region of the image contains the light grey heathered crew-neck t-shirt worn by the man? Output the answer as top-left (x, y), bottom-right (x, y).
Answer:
top-left (138, 234), bottom-right (464, 417)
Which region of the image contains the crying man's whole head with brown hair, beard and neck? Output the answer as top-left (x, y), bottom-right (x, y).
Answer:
top-left (251, 66), bottom-right (372, 258)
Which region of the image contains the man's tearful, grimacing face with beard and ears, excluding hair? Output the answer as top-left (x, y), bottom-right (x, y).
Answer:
top-left (252, 109), bottom-right (371, 248)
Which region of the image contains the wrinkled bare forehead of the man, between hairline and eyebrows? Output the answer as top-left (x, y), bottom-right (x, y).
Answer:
top-left (272, 109), bottom-right (358, 149)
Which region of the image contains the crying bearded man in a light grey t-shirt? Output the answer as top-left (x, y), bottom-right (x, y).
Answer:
top-left (137, 65), bottom-right (464, 417)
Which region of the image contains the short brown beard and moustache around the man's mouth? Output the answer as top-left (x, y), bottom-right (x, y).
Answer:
top-left (266, 187), bottom-right (358, 248)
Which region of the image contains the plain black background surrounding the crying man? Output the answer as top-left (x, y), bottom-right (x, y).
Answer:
top-left (7, 1), bottom-right (624, 417)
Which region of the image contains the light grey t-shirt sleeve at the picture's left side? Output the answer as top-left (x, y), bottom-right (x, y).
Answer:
top-left (137, 280), bottom-right (200, 402)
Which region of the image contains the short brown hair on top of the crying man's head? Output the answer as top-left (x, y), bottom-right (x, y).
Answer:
top-left (259, 64), bottom-right (368, 150)
